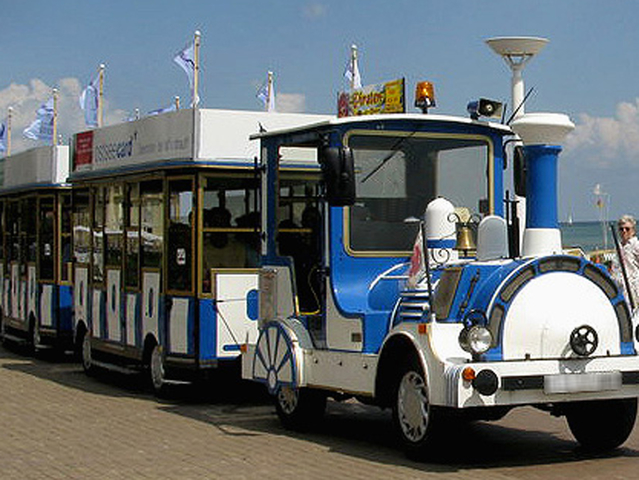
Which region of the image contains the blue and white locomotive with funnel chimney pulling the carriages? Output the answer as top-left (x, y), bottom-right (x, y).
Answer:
top-left (243, 77), bottom-right (639, 454)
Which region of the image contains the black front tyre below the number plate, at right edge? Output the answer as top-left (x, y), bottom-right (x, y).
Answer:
top-left (566, 398), bottom-right (637, 452)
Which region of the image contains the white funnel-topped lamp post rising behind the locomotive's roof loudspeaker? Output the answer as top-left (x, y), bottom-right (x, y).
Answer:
top-left (486, 37), bottom-right (548, 121)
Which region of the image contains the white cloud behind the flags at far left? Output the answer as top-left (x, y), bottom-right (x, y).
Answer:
top-left (0, 77), bottom-right (126, 153)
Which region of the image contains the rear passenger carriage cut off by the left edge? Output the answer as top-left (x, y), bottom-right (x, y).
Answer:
top-left (0, 146), bottom-right (73, 351)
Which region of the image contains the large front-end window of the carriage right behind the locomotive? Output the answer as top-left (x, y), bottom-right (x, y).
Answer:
top-left (202, 175), bottom-right (260, 292)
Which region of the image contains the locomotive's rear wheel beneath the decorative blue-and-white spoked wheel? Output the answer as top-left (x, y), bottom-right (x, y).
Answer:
top-left (275, 386), bottom-right (326, 431)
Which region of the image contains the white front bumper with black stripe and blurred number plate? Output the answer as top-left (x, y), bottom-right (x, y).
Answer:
top-left (444, 355), bottom-right (639, 408)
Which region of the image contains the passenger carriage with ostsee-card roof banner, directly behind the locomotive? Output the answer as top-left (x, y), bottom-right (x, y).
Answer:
top-left (70, 109), bottom-right (324, 391)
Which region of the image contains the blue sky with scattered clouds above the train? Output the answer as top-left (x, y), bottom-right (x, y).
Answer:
top-left (0, 0), bottom-right (639, 221)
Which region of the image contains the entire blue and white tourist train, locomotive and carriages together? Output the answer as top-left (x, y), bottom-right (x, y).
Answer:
top-left (0, 35), bottom-right (639, 455)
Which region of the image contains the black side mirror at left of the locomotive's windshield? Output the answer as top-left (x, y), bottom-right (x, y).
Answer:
top-left (318, 147), bottom-right (355, 207)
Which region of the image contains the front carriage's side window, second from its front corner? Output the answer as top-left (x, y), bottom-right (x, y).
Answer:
top-left (140, 180), bottom-right (164, 268)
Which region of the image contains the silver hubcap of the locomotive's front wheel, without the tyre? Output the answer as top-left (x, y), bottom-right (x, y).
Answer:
top-left (397, 372), bottom-right (428, 442)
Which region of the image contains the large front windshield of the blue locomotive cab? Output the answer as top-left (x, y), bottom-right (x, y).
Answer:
top-left (348, 132), bottom-right (489, 252)
